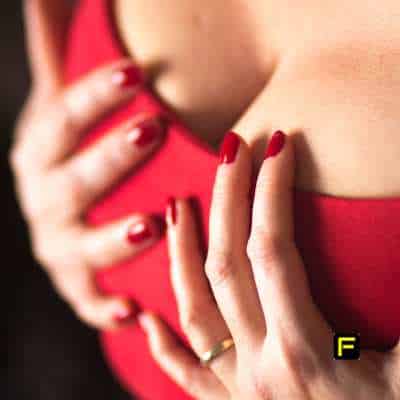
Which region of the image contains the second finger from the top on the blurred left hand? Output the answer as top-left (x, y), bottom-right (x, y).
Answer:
top-left (60, 115), bottom-right (164, 214)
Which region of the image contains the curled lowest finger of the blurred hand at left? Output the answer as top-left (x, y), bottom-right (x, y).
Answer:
top-left (50, 265), bottom-right (137, 330)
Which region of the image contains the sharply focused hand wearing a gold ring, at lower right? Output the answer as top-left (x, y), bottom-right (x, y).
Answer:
top-left (139, 132), bottom-right (400, 400)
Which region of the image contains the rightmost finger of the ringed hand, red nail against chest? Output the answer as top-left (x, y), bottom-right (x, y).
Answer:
top-left (248, 132), bottom-right (328, 336)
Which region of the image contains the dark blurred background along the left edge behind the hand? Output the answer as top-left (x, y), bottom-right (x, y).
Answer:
top-left (0, 0), bottom-right (129, 400)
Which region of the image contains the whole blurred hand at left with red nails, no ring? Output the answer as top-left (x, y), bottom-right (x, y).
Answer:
top-left (10, 0), bottom-right (164, 329)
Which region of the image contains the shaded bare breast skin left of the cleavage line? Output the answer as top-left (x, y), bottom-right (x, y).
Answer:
top-left (114, 0), bottom-right (271, 144)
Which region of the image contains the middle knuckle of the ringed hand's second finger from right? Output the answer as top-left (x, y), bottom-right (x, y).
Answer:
top-left (205, 250), bottom-right (236, 286)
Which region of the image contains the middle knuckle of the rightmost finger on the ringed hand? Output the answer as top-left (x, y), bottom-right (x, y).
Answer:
top-left (246, 228), bottom-right (289, 264)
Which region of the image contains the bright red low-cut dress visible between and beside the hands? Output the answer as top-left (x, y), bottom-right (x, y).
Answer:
top-left (65, 0), bottom-right (400, 400)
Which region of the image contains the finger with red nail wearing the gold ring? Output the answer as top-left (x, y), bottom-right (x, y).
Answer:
top-left (167, 199), bottom-right (236, 382)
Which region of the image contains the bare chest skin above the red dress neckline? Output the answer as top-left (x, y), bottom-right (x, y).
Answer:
top-left (114, 0), bottom-right (400, 197)
